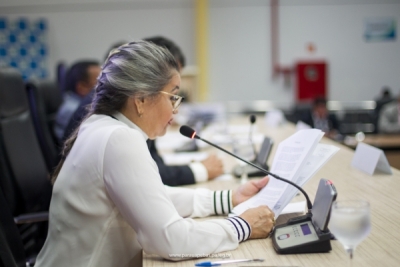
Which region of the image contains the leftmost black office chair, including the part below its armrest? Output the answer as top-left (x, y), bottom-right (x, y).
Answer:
top-left (0, 68), bottom-right (52, 262)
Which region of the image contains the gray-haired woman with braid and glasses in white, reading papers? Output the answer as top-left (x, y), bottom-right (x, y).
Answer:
top-left (35, 41), bottom-right (275, 267)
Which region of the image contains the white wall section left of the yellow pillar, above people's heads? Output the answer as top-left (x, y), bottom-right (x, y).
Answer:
top-left (0, 0), bottom-right (194, 77)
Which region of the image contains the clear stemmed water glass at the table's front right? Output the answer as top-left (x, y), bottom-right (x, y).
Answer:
top-left (329, 200), bottom-right (371, 264)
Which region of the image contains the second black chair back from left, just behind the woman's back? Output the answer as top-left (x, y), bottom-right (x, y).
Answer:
top-left (26, 80), bottom-right (63, 172)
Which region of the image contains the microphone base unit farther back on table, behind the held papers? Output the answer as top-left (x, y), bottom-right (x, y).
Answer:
top-left (232, 137), bottom-right (273, 177)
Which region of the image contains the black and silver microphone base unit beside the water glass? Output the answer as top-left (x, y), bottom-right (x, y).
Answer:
top-left (271, 179), bottom-right (337, 254)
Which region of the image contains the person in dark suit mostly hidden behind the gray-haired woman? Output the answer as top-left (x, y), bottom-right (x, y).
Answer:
top-left (63, 36), bottom-right (224, 186)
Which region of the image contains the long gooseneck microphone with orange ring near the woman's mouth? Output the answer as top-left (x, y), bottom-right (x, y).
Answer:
top-left (179, 125), bottom-right (312, 214)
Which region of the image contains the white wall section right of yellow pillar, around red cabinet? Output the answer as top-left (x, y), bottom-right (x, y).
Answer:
top-left (210, 0), bottom-right (400, 103)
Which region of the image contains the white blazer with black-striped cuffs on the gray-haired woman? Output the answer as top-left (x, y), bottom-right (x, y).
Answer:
top-left (35, 113), bottom-right (242, 267)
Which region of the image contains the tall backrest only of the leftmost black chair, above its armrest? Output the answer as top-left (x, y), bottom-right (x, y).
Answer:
top-left (0, 68), bottom-right (52, 215)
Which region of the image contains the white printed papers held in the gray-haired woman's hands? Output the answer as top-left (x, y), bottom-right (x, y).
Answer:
top-left (233, 129), bottom-right (330, 217)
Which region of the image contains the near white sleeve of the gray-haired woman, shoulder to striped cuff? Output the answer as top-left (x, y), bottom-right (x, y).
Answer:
top-left (103, 128), bottom-right (239, 260)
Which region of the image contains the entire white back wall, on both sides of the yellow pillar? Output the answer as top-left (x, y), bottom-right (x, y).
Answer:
top-left (0, 0), bottom-right (400, 103)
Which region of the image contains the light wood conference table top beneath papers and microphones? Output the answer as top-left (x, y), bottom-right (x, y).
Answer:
top-left (143, 119), bottom-right (400, 267)
